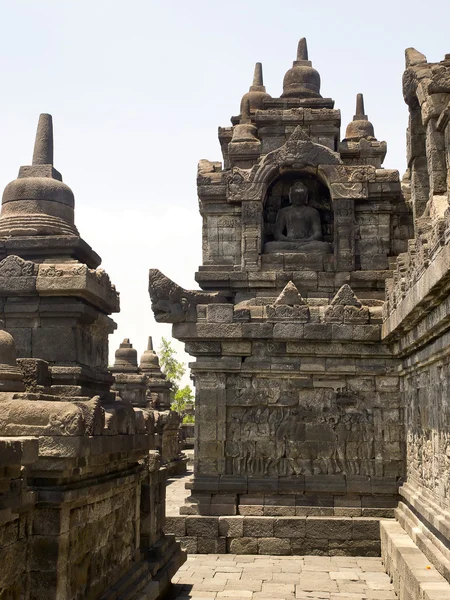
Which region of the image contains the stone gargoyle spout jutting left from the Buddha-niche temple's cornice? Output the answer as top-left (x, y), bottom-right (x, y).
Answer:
top-left (148, 269), bottom-right (227, 323)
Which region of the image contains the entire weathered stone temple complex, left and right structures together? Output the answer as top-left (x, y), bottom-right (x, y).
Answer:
top-left (0, 39), bottom-right (450, 600)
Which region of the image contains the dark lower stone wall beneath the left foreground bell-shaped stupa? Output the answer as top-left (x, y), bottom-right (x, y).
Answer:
top-left (0, 393), bottom-right (183, 600)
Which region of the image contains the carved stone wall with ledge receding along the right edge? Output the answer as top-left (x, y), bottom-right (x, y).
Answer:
top-left (382, 48), bottom-right (450, 600)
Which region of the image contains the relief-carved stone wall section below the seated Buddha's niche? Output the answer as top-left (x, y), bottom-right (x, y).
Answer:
top-left (174, 284), bottom-right (405, 516)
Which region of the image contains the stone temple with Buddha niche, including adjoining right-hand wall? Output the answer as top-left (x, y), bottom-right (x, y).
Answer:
top-left (149, 39), bottom-right (450, 599)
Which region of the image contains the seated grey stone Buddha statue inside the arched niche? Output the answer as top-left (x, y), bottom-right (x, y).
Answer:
top-left (264, 181), bottom-right (331, 254)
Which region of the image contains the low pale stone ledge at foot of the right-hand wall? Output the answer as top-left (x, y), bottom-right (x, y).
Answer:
top-left (380, 521), bottom-right (450, 600)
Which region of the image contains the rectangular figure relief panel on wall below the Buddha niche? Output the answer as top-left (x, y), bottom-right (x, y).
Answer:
top-left (225, 396), bottom-right (375, 476)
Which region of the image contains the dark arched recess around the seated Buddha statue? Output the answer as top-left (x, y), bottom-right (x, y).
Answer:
top-left (263, 171), bottom-right (334, 246)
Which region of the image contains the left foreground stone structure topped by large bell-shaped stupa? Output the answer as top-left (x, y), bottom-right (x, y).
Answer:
top-left (0, 115), bottom-right (185, 600)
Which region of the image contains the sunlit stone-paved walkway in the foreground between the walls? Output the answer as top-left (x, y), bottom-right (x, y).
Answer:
top-left (171, 554), bottom-right (397, 600)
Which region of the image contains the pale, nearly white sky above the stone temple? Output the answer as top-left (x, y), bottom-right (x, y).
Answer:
top-left (0, 0), bottom-right (450, 384)
